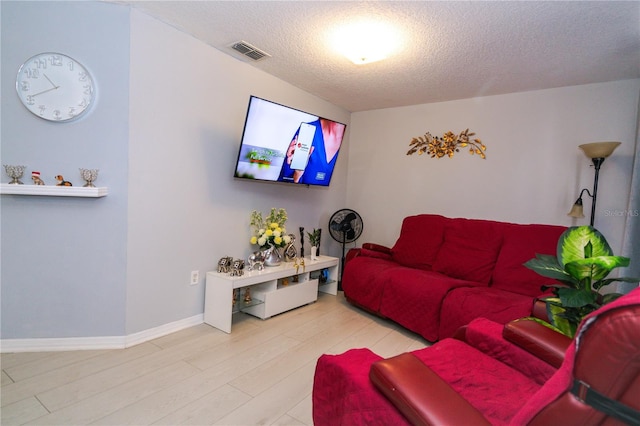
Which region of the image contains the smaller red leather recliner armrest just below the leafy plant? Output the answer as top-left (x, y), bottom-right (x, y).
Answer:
top-left (502, 319), bottom-right (571, 368)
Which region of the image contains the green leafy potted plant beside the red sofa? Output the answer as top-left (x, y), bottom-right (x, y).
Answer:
top-left (524, 226), bottom-right (640, 337)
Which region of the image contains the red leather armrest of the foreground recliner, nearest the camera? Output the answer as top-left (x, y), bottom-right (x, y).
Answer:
top-left (369, 353), bottom-right (490, 425)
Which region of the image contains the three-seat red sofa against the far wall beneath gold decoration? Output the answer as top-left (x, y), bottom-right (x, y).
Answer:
top-left (342, 214), bottom-right (566, 342)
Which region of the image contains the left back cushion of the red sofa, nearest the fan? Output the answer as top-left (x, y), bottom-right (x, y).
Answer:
top-left (391, 214), bottom-right (450, 270)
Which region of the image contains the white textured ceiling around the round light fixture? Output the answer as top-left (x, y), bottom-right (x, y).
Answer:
top-left (112, 1), bottom-right (640, 112)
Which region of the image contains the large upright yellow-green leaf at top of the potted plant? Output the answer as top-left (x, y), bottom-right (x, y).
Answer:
top-left (557, 226), bottom-right (613, 267)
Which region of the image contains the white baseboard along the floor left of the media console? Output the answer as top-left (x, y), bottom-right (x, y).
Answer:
top-left (0, 314), bottom-right (204, 353)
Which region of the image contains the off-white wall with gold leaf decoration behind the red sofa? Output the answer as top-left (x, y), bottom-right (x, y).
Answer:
top-left (347, 80), bottom-right (640, 254)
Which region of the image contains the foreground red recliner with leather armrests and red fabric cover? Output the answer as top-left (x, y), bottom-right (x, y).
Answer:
top-left (313, 289), bottom-right (640, 426)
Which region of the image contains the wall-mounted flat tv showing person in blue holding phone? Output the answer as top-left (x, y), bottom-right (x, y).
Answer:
top-left (235, 96), bottom-right (347, 186)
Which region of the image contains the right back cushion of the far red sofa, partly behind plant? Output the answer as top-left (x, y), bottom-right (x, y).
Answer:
top-left (491, 224), bottom-right (567, 296)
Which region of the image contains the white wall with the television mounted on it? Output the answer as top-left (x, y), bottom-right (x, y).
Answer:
top-left (127, 11), bottom-right (350, 334)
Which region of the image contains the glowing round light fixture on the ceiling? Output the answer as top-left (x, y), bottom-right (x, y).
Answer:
top-left (331, 20), bottom-right (401, 65)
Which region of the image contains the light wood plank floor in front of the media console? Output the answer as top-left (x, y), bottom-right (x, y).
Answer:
top-left (1, 293), bottom-right (428, 425)
